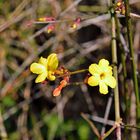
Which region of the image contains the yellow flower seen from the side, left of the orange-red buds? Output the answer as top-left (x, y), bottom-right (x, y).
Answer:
top-left (30, 53), bottom-right (58, 83)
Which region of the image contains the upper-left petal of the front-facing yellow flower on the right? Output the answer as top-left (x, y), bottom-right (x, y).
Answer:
top-left (89, 64), bottom-right (102, 75)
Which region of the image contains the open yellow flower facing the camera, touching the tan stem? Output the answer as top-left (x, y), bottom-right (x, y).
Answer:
top-left (88, 59), bottom-right (116, 94)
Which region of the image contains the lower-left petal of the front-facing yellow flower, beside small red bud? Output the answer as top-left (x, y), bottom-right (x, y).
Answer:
top-left (88, 75), bottom-right (100, 86)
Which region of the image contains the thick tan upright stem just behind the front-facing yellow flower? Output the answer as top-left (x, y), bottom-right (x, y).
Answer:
top-left (110, 0), bottom-right (121, 140)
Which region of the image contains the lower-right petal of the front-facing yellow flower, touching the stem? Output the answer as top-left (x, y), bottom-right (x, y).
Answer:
top-left (104, 76), bottom-right (116, 88)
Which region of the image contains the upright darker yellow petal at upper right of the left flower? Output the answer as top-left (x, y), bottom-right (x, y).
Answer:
top-left (47, 53), bottom-right (58, 71)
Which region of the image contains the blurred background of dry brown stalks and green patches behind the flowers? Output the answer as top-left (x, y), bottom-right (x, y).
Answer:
top-left (0, 0), bottom-right (140, 140)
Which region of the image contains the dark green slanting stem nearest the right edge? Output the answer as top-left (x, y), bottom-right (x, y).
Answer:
top-left (124, 0), bottom-right (140, 121)
